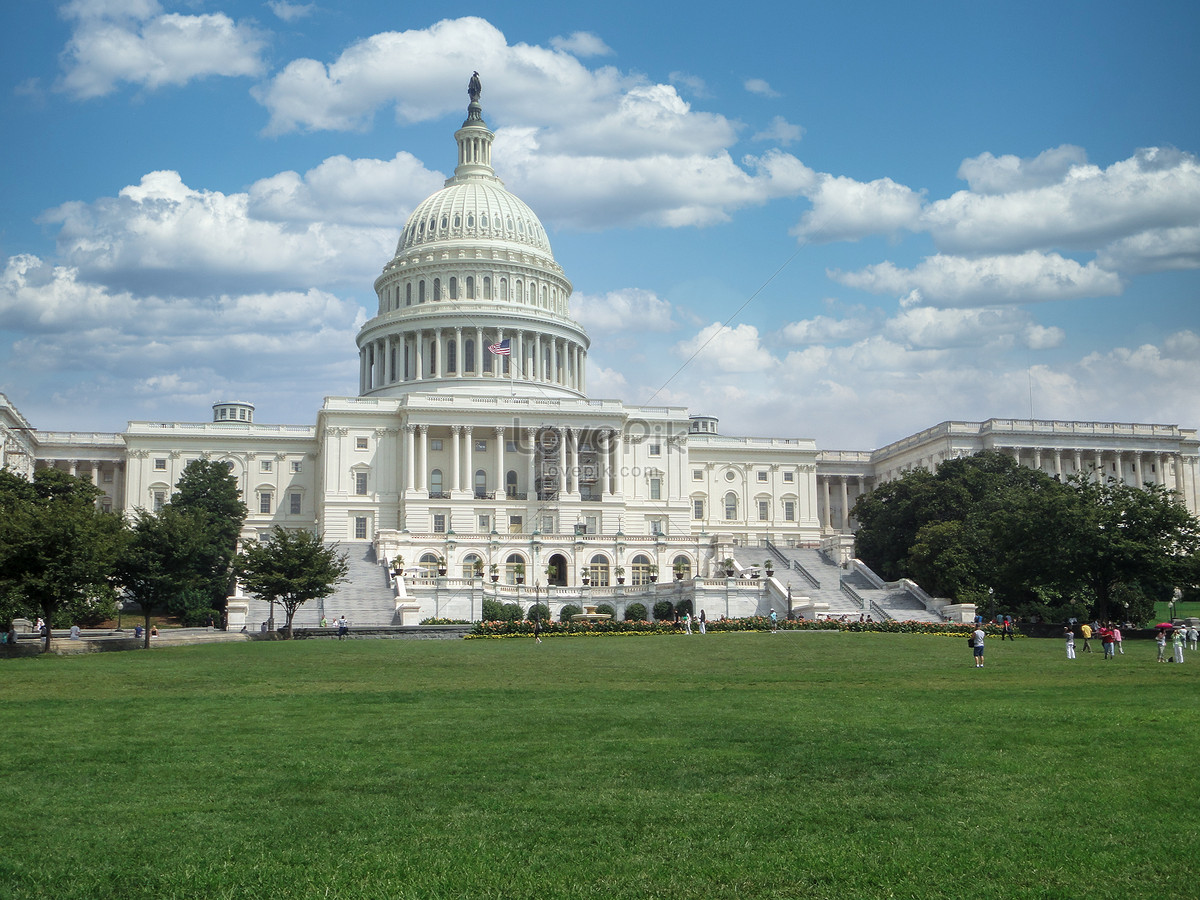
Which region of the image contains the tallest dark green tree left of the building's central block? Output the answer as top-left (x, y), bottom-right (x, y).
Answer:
top-left (167, 460), bottom-right (247, 624)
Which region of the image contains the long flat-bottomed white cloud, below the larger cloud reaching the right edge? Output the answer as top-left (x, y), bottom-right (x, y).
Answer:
top-left (829, 251), bottom-right (1122, 307)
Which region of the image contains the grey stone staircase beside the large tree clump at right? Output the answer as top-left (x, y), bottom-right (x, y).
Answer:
top-left (760, 547), bottom-right (942, 622)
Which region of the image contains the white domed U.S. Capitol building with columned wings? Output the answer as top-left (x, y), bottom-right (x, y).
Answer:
top-left (0, 88), bottom-right (1198, 624)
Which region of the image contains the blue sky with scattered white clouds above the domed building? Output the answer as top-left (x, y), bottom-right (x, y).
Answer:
top-left (0, 0), bottom-right (1200, 449)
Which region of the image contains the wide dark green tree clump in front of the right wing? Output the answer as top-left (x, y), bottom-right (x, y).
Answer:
top-left (853, 451), bottom-right (1200, 622)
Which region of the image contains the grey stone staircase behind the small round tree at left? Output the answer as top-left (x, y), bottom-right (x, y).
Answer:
top-left (246, 544), bottom-right (396, 631)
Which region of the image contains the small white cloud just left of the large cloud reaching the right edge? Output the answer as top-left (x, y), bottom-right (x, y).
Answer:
top-left (792, 175), bottom-right (922, 242)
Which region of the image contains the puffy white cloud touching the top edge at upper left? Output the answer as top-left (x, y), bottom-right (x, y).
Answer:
top-left (58, 0), bottom-right (265, 100)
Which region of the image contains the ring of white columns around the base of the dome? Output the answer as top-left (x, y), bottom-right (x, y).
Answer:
top-left (359, 325), bottom-right (587, 394)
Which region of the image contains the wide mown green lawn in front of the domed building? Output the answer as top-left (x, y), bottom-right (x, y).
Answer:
top-left (0, 632), bottom-right (1200, 900)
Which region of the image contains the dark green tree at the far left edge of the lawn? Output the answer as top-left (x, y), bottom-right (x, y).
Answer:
top-left (0, 469), bottom-right (125, 650)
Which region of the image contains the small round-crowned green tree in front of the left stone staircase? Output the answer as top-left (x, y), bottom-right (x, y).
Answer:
top-left (235, 526), bottom-right (349, 640)
